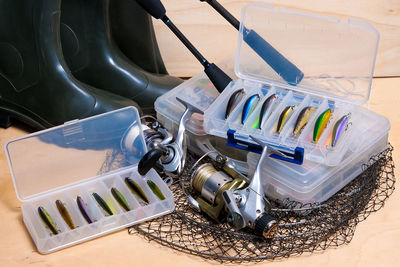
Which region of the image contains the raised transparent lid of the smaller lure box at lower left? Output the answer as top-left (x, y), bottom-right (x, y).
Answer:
top-left (5, 107), bottom-right (147, 201)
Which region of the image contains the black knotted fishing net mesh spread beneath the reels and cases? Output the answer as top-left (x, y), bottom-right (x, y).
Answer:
top-left (128, 146), bottom-right (395, 263)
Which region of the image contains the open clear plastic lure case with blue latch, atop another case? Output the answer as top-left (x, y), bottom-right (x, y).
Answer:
top-left (204, 2), bottom-right (382, 166)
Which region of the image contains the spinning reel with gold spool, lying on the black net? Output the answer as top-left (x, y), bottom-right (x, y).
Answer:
top-left (189, 137), bottom-right (278, 239)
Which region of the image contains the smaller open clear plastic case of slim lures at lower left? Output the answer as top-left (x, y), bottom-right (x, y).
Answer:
top-left (5, 107), bottom-right (174, 253)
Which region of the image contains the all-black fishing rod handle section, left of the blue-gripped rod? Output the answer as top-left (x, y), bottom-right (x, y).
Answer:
top-left (136, 0), bottom-right (232, 93)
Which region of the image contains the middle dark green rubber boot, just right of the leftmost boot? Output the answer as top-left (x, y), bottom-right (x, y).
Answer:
top-left (61, 0), bottom-right (182, 114)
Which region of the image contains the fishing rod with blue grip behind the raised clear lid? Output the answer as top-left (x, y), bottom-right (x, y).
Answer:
top-left (200, 0), bottom-right (304, 85)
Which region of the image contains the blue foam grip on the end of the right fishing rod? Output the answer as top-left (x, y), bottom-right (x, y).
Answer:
top-left (243, 29), bottom-right (304, 85)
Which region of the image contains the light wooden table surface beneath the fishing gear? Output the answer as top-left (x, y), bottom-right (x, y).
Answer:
top-left (0, 78), bottom-right (400, 267)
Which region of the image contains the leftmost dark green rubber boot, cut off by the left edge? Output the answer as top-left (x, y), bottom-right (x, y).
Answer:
top-left (0, 0), bottom-right (141, 129)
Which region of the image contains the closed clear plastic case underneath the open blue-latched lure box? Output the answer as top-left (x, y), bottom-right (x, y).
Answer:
top-left (155, 54), bottom-right (390, 203)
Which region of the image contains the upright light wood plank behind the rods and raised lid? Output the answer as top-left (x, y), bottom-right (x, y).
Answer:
top-left (154, 0), bottom-right (400, 77)
